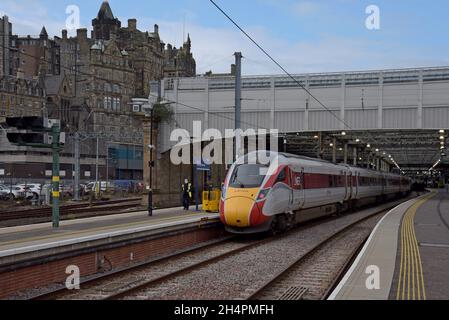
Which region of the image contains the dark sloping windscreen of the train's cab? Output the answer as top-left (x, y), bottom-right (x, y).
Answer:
top-left (229, 164), bottom-right (268, 189)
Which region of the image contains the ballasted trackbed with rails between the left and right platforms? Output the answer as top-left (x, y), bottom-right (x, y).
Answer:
top-left (30, 200), bottom-right (400, 300)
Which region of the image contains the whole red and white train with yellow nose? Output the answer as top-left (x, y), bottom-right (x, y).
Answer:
top-left (220, 151), bottom-right (411, 233)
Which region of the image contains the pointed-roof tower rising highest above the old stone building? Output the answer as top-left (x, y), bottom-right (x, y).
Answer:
top-left (92, 1), bottom-right (122, 40)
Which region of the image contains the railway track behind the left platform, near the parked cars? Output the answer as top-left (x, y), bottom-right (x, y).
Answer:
top-left (0, 198), bottom-right (141, 222)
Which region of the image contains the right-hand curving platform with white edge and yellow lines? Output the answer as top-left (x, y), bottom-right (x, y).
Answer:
top-left (329, 190), bottom-right (449, 300)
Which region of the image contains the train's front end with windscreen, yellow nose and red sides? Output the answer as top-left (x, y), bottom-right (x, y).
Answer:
top-left (220, 164), bottom-right (272, 233)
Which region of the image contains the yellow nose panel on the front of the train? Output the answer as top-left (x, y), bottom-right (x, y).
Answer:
top-left (225, 197), bottom-right (254, 228)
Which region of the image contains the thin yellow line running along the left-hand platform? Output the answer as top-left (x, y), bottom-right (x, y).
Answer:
top-left (0, 213), bottom-right (214, 248)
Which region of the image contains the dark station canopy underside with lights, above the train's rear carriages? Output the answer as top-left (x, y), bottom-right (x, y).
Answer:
top-left (280, 130), bottom-right (449, 172)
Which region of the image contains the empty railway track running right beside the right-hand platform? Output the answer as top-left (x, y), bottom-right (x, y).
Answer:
top-left (247, 210), bottom-right (388, 300)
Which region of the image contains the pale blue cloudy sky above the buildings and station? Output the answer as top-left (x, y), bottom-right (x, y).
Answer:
top-left (0, 0), bottom-right (449, 74)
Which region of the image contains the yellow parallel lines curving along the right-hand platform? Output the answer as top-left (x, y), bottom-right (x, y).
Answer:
top-left (396, 193), bottom-right (436, 300)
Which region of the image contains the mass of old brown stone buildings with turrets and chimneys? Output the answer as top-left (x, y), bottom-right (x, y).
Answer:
top-left (0, 1), bottom-right (196, 184)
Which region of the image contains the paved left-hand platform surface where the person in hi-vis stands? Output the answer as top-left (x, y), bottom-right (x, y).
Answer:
top-left (0, 208), bottom-right (219, 269)
